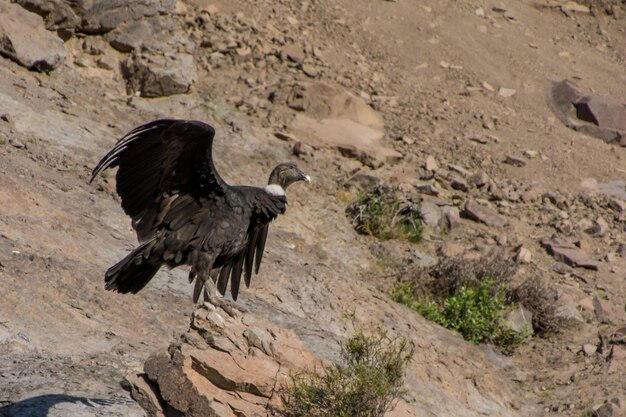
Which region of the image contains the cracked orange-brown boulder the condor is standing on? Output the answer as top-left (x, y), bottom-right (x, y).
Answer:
top-left (123, 303), bottom-right (319, 417)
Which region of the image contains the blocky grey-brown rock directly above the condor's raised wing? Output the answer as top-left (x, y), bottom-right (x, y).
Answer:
top-left (122, 53), bottom-right (198, 97)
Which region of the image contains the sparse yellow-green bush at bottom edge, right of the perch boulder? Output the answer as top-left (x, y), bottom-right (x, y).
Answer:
top-left (278, 332), bottom-right (413, 417)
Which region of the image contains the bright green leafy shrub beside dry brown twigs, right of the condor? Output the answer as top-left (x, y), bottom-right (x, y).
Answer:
top-left (391, 277), bottom-right (530, 353)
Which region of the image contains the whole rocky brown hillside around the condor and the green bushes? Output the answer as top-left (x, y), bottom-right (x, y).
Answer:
top-left (0, 0), bottom-right (626, 416)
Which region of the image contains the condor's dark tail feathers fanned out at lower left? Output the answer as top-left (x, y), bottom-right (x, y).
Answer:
top-left (104, 241), bottom-right (163, 294)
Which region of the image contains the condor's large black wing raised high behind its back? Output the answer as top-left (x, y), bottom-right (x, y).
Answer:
top-left (90, 119), bottom-right (229, 242)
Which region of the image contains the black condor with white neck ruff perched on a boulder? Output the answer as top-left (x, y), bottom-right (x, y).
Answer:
top-left (90, 119), bottom-right (310, 302)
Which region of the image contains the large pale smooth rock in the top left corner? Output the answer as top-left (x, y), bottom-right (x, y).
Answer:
top-left (0, 2), bottom-right (67, 71)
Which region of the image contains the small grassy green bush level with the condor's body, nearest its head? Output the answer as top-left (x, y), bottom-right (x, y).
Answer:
top-left (346, 185), bottom-right (423, 243)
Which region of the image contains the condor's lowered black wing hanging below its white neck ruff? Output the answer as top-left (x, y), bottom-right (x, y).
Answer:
top-left (217, 187), bottom-right (287, 300)
